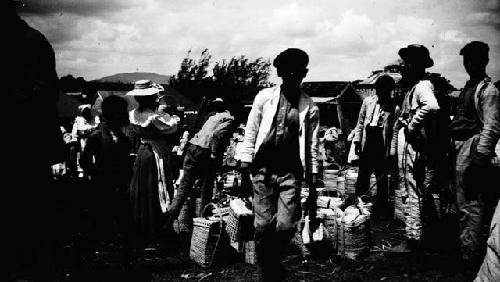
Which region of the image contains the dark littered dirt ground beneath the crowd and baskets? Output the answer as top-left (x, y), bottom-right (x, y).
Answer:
top-left (49, 177), bottom-right (474, 282)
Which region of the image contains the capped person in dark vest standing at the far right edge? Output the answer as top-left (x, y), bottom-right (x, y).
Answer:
top-left (450, 41), bottom-right (500, 272)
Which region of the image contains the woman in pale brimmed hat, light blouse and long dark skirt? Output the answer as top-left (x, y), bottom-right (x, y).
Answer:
top-left (127, 80), bottom-right (179, 244)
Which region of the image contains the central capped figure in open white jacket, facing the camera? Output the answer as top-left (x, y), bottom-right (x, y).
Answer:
top-left (240, 48), bottom-right (319, 281)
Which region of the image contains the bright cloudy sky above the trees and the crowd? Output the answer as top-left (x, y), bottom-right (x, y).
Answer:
top-left (21, 0), bottom-right (500, 88)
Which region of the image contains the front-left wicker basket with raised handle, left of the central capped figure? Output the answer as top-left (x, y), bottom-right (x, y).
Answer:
top-left (189, 203), bottom-right (224, 267)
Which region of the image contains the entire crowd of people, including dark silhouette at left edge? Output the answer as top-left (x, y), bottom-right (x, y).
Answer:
top-left (5, 2), bottom-right (500, 281)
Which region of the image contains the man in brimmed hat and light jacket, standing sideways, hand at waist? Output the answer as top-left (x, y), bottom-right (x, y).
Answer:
top-left (395, 44), bottom-right (439, 251)
